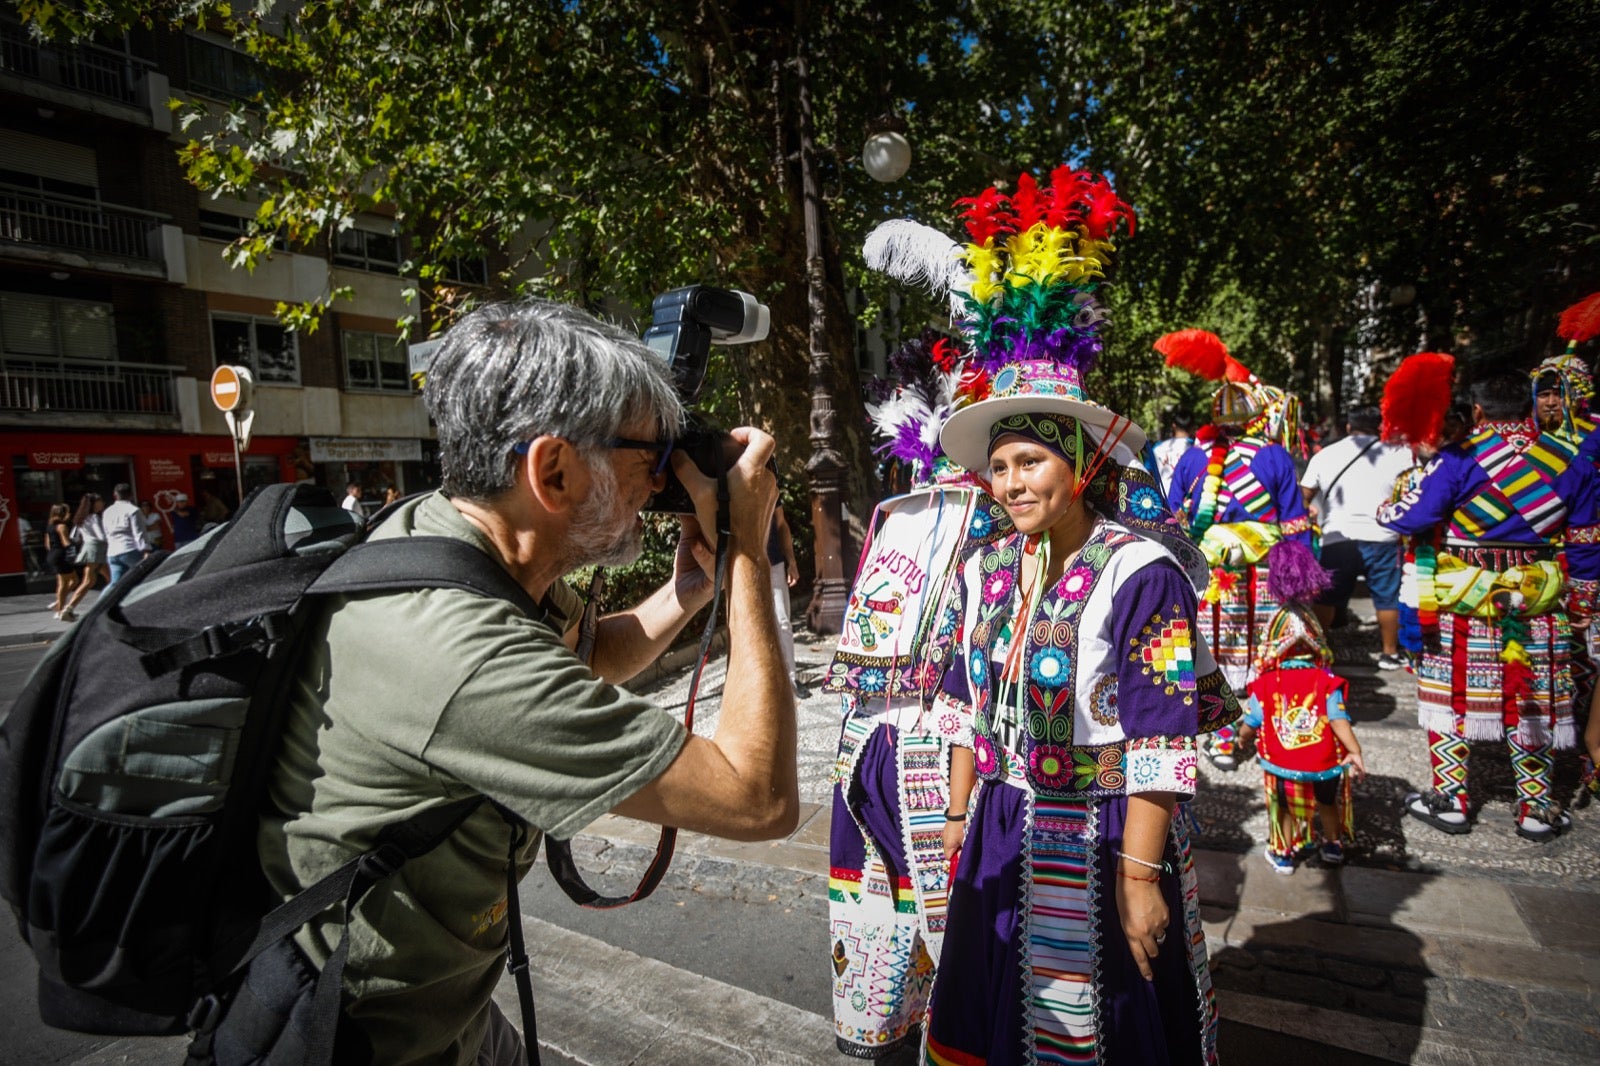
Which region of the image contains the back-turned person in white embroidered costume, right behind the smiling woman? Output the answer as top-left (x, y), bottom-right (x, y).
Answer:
top-left (822, 331), bottom-right (1010, 1058)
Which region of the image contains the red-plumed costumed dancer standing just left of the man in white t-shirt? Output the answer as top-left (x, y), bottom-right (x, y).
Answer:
top-left (1155, 330), bottom-right (1328, 770)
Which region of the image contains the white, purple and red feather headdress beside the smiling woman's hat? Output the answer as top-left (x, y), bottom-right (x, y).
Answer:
top-left (866, 330), bottom-right (963, 483)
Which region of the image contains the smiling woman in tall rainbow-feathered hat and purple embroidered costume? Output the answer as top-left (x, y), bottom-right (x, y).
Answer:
top-left (870, 168), bottom-right (1238, 1066)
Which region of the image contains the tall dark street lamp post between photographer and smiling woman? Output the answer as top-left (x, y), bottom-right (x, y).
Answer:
top-left (795, 38), bottom-right (850, 634)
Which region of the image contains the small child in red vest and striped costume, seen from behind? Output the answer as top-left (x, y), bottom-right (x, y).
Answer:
top-left (1238, 601), bottom-right (1366, 874)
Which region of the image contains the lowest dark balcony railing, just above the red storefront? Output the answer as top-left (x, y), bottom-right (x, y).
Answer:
top-left (0, 355), bottom-right (179, 415)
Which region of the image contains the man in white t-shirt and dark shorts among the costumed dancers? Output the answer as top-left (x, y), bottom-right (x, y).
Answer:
top-left (1301, 407), bottom-right (1411, 671)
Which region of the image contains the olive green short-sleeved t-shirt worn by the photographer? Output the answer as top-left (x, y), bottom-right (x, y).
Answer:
top-left (258, 493), bottom-right (686, 1063)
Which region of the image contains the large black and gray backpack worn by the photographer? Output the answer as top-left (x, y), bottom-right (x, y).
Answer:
top-left (0, 485), bottom-right (542, 1063)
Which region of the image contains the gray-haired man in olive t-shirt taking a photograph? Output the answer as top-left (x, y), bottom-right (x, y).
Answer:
top-left (258, 294), bottom-right (798, 1064)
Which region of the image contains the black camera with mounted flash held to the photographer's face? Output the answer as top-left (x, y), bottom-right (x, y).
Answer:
top-left (643, 285), bottom-right (771, 514)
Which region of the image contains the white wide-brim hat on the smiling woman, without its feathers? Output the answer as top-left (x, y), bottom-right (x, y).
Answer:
top-left (939, 360), bottom-right (1146, 474)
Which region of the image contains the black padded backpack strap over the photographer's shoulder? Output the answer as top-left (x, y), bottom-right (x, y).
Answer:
top-left (307, 536), bottom-right (549, 621)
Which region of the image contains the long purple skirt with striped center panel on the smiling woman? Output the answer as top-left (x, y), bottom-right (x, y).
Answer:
top-left (925, 771), bottom-right (1216, 1066)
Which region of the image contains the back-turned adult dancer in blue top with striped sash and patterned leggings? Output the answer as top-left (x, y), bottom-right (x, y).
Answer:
top-left (1378, 373), bottom-right (1600, 840)
